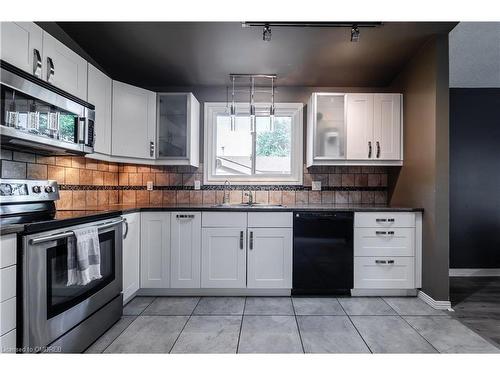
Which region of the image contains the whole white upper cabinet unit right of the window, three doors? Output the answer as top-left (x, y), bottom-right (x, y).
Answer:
top-left (307, 93), bottom-right (403, 167)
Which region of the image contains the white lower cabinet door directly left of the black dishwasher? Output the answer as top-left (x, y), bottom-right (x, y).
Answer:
top-left (247, 228), bottom-right (292, 288)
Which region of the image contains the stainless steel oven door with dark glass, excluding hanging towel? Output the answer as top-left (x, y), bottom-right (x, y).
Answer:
top-left (23, 219), bottom-right (122, 348)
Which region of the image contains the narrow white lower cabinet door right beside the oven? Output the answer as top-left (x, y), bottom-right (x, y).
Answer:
top-left (123, 213), bottom-right (141, 303)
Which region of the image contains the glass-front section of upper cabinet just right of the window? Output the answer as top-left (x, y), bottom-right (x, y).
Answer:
top-left (307, 93), bottom-right (346, 167)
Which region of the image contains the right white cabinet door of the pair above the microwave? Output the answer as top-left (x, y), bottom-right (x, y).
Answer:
top-left (42, 32), bottom-right (87, 100)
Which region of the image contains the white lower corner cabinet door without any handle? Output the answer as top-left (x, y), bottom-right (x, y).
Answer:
top-left (141, 212), bottom-right (170, 288)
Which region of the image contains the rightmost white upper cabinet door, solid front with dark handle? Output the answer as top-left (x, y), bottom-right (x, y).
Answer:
top-left (373, 94), bottom-right (402, 160)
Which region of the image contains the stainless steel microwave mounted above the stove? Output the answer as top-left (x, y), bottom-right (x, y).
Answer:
top-left (0, 61), bottom-right (95, 155)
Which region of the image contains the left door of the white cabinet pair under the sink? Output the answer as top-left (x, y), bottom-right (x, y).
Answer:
top-left (201, 227), bottom-right (247, 288)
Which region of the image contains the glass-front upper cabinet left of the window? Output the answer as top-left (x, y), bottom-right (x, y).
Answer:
top-left (157, 93), bottom-right (200, 167)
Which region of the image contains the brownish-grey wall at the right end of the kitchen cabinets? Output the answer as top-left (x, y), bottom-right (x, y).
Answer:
top-left (389, 35), bottom-right (449, 301)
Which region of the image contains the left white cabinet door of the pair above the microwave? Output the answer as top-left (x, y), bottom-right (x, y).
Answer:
top-left (0, 22), bottom-right (43, 78)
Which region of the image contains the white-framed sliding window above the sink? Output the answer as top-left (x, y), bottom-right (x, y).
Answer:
top-left (204, 103), bottom-right (303, 185)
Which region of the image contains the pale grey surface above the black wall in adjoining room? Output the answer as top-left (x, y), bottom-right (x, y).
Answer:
top-left (449, 22), bottom-right (500, 87)
